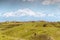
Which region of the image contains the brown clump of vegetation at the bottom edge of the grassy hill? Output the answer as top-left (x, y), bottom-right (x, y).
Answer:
top-left (29, 34), bottom-right (53, 40)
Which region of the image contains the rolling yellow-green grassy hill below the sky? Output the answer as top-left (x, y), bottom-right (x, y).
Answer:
top-left (0, 21), bottom-right (60, 40)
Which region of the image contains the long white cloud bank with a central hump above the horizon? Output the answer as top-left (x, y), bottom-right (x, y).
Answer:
top-left (2, 9), bottom-right (54, 17)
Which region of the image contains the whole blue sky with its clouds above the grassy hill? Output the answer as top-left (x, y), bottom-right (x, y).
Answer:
top-left (0, 0), bottom-right (60, 22)
